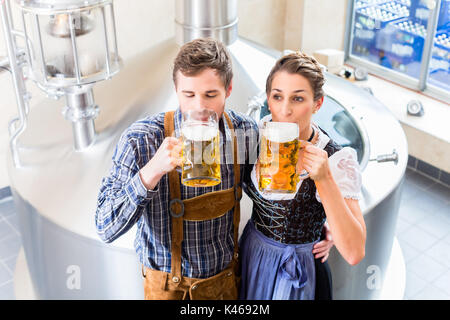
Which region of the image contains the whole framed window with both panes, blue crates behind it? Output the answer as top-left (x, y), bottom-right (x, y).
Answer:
top-left (346, 0), bottom-right (450, 101)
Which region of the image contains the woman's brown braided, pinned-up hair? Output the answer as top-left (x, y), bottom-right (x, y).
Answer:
top-left (266, 52), bottom-right (325, 101)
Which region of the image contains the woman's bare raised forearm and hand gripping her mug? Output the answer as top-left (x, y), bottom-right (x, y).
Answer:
top-left (302, 145), bottom-right (366, 265)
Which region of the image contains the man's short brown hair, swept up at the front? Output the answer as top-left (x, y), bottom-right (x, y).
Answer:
top-left (172, 38), bottom-right (233, 89)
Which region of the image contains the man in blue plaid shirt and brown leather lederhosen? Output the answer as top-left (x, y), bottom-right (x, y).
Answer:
top-left (96, 39), bottom-right (258, 299)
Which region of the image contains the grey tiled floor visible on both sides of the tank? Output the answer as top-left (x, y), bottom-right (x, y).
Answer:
top-left (0, 169), bottom-right (450, 300)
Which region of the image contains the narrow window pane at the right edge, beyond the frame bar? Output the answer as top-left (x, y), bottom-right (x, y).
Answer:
top-left (428, 0), bottom-right (450, 92)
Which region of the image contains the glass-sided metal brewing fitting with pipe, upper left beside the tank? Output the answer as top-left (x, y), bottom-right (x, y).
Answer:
top-left (0, 0), bottom-right (121, 167)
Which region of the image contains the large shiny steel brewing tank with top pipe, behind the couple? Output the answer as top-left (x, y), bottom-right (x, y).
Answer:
top-left (8, 0), bottom-right (408, 299)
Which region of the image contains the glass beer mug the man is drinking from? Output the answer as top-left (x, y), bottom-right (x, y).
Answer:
top-left (181, 109), bottom-right (221, 187)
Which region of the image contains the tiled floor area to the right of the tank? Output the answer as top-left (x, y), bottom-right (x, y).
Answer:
top-left (396, 169), bottom-right (450, 300)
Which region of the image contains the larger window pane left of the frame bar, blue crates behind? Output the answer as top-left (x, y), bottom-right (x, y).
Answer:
top-left (351, 0), bottom-right (429, 79)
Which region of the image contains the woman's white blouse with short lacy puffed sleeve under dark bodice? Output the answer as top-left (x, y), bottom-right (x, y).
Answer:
top-left (250, 115), bottom-right (362, 202)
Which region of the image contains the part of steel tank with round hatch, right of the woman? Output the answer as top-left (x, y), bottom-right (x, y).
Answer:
top-left (315, 74), bottom-right (408, 299)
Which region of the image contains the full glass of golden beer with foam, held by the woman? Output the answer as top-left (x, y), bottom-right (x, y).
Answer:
top-left (259, 122), bottom-right (300, 193)
